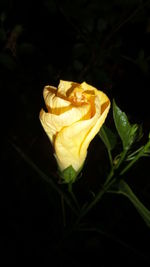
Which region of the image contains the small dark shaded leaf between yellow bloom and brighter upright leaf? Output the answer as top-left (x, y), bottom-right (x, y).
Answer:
top-left (99, 125), bottom-right (117, 150)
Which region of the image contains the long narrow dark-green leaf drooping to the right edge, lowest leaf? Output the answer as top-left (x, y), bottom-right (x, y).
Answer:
top-left (110, 180), bottom-right (150, 227)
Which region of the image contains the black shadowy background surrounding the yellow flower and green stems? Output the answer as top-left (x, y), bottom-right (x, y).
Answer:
top-left (0, 0), bottom-right (150, 266)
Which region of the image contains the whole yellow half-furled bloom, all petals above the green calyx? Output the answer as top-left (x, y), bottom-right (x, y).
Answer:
top-left (40, 80), bottom-right (110, 183)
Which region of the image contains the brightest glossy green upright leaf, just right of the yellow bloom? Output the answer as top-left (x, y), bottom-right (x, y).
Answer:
top-left (113, 100), bottom-right (138, 150)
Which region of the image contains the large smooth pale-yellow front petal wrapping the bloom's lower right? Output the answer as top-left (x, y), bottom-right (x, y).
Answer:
top-left (54, 97), bottom-right (109, 171)
